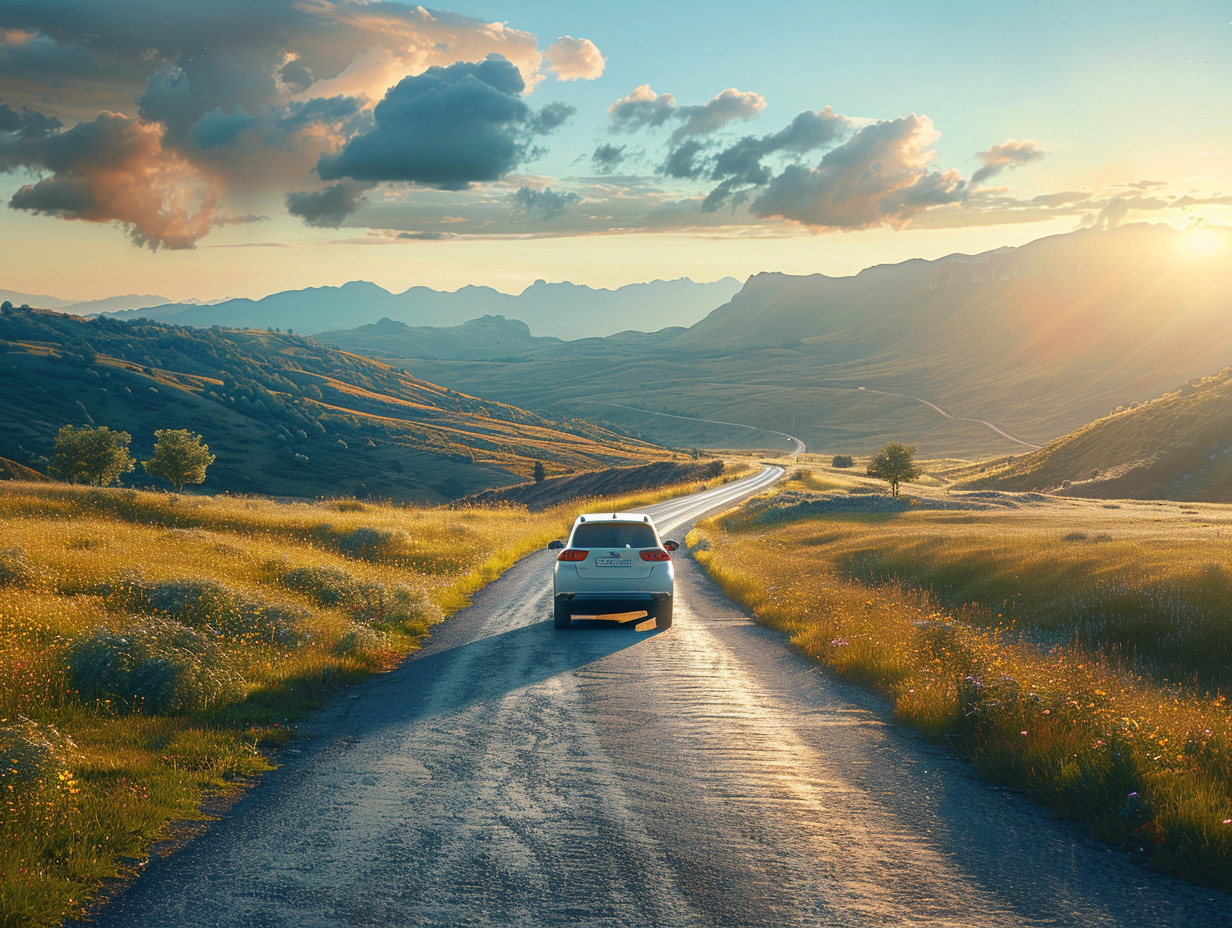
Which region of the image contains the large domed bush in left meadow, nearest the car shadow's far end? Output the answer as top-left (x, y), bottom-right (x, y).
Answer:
top-left (68, 615), bottom-right (243, 714)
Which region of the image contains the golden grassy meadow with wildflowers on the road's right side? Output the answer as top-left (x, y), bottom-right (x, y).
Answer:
top-left (689, 467), bottom-right (1232, 890)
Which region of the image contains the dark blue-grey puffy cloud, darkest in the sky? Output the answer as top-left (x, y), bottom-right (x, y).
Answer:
top-left (317, 55), bottom-right (535, 190)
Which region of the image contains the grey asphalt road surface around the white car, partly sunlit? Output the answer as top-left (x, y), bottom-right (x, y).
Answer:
top-left (100, 472), bottom-right (1232, 928)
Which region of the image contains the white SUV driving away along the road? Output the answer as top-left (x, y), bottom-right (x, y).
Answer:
top-left (548, 513), bottom-right (680, 629)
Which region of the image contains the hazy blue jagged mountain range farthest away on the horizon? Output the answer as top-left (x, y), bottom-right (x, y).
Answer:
top-left (96, 277), bottom-right (740, 340)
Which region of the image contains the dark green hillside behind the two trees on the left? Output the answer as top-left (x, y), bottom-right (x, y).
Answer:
top-left (0, 309), bottom-right (669, 502)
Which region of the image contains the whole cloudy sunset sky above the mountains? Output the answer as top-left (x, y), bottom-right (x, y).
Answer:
top-left (0, 0), bottom-right (1232, 299)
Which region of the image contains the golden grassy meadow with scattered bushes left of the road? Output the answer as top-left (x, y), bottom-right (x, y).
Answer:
top-left (0, 470), bottom-right (723, 926)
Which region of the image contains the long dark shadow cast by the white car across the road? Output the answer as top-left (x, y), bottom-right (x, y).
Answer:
top-left (354, 617), bottom-right (663, 723)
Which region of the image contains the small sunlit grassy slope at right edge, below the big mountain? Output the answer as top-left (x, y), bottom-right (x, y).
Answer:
top-left (956, 367), bottom-right (1232, 503)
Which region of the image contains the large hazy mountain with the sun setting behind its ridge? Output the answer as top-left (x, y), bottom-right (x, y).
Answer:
top-left (357, 226), bottom-right (1232, 456)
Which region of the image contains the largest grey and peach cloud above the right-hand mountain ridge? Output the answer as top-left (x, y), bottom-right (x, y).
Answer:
top-left (750, 113), bottom-right (966, 230)
